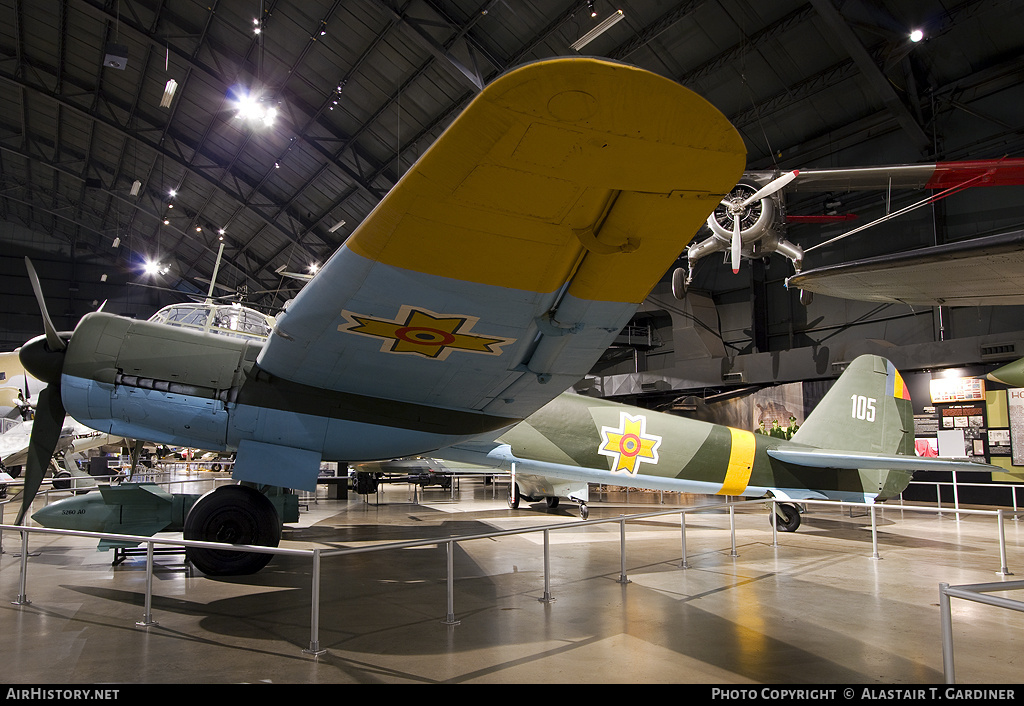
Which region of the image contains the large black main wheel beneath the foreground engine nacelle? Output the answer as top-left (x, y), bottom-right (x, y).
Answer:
top-left (182, 486), bottom-right (281, 576)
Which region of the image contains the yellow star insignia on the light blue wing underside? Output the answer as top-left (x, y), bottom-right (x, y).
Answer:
top-left (338, 305), bottom-right (515, 361)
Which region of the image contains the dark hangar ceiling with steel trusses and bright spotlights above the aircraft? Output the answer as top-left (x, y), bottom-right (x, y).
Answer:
top-left (0, 0), bottom-right (1024, 387)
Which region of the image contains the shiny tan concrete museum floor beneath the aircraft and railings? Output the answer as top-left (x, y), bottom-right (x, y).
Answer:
top-left (0, 480), bottom-right (1024, 684)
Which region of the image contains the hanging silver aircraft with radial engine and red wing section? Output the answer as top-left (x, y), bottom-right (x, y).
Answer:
top-left (672, 159), bottom-right (1024, 304)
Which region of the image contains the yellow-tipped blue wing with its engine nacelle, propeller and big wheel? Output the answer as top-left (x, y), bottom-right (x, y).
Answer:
top-left (18, 57), bottom-right (744, 574)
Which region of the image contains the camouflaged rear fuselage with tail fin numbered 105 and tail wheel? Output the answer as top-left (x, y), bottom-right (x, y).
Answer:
top-left (441, 356), bottom-right (997, 522)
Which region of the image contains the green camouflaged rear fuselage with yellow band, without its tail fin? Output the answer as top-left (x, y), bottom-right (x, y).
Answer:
top-left (442, 393), bottom-right (910, 502)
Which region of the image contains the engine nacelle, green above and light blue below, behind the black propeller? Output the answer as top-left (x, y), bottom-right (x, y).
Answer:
top-left (52, 313), bottom-right (516, 488)
